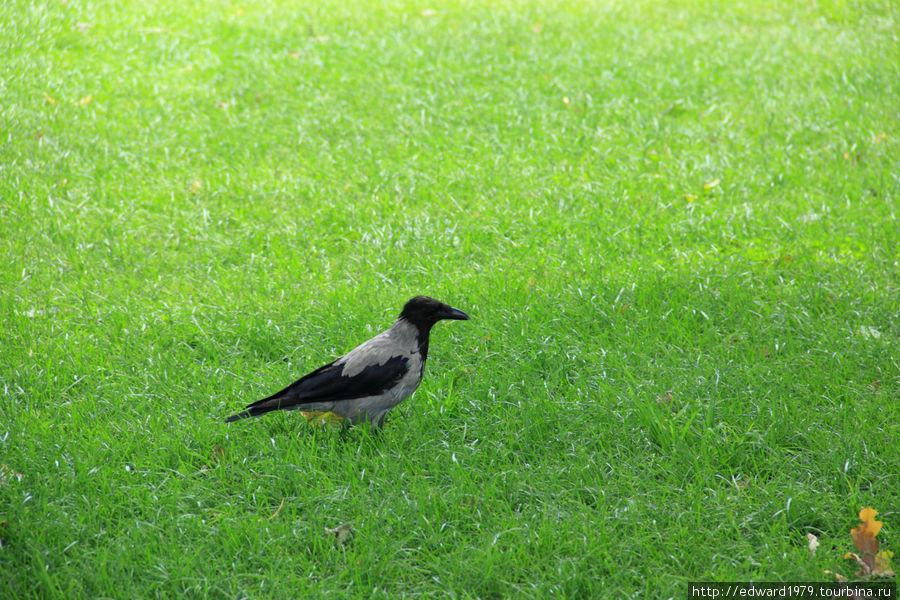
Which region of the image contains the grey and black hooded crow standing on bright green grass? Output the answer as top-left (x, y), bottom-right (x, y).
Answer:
top-left (226, 296), bottom-right (469, 427)
